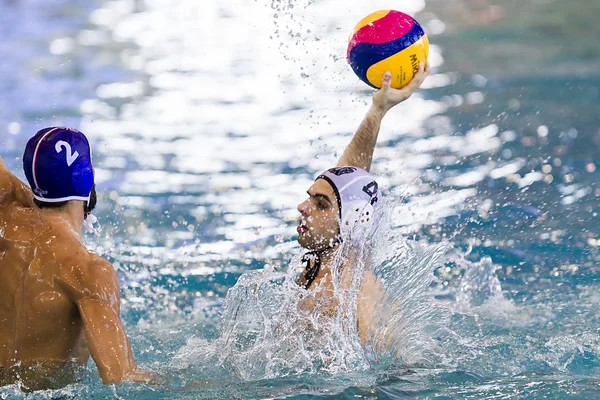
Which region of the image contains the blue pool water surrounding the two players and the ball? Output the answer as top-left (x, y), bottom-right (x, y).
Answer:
top-left (0, 0), bottom-right (600, 399)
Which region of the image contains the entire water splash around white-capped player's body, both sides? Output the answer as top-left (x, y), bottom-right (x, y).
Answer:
top-left (173, 203), bottom-right (448, 380)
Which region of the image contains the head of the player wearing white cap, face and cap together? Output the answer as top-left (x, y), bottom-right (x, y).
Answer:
top-left (297, 167), bottom-right (381, 251)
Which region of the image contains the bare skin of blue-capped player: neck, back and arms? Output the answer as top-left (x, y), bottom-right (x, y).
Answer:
top-left (0, 158), bottom-right (149, 391)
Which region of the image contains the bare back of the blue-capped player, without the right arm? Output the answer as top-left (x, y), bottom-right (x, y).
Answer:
top-left (0, 176), bottom-right (92, 387)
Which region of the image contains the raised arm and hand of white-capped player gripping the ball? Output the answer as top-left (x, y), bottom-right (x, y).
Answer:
top-left (337, 63), bottom-right (430, 171)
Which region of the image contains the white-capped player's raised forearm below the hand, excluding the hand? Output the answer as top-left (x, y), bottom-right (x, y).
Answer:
top-left (338, 105), bottom-right (386, 171)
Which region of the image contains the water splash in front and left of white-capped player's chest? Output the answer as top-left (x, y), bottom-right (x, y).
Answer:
top-left (174, 260), bottom-right (369, 380)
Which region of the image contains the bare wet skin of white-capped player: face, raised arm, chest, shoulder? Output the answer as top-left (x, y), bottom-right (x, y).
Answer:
top-left (297, 64), bottom-right (431, 343)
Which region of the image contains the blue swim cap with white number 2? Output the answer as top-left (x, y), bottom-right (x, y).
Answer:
top-left (23, 127), bottom-right (94, 203)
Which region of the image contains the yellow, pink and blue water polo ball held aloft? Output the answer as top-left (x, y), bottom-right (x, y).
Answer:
top-left (347, 10), bottom-right (429, 89)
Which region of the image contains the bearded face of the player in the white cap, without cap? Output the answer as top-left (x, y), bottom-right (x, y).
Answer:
top-left (297, 179), bottom-right (340, 250)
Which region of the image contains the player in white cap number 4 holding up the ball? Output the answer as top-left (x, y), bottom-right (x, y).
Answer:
top-left (297, 64), bottom-right (430, 343)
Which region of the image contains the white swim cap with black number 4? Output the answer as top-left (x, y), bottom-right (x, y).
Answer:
top-left (317, 167), bottom-right (381, 238)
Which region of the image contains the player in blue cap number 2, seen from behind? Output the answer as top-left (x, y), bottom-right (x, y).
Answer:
top-left (0, 127), bottom-right (155, 391)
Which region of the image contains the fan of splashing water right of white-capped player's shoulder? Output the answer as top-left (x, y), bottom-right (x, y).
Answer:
top-left (369, 236), bottom-right (450, 364)
